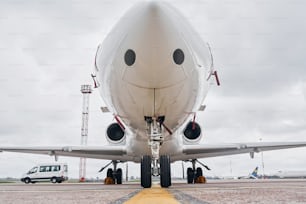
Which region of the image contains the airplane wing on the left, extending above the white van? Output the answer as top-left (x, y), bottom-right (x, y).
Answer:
top-left (0, 146), bottom-right (132, 161)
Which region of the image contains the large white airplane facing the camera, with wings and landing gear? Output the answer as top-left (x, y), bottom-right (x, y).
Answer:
top-left (0, 2), bottom-right (306, 188)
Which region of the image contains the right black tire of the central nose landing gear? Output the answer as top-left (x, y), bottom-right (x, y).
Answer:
top-left (159, 155), bottom-right (171, 188)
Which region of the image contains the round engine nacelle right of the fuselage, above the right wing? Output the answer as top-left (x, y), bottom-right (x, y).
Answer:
top-left (183, 122), bottom-right (202, 144)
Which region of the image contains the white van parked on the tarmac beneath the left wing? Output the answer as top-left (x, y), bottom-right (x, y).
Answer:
top-left (21, 163), bottom-right (68, 184)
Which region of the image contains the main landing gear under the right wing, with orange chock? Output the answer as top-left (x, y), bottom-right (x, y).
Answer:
top-left (187, 159), bottom-right (210, 184)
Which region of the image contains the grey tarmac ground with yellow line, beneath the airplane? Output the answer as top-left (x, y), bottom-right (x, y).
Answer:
top-left (0, 179), bottom-right (306, 204)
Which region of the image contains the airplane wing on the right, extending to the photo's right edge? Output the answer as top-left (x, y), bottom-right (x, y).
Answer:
top-left (171, 142), bottom-right (306, 161)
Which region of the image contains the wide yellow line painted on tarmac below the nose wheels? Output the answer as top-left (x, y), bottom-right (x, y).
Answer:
top-left (125, 185), bottom-right (179, 204)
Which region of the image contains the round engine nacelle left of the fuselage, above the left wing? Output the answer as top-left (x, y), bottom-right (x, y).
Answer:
top-left (106, 123), bottom-right (125, 144)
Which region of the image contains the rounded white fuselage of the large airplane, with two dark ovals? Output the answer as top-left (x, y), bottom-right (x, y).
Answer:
top-left (96, 2), bottom-right (212, 157)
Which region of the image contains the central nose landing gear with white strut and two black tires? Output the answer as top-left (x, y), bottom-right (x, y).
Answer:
top-left (140, 117), bottom-right (171, 188)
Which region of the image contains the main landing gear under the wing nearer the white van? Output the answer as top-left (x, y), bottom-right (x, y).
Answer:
top-left (99, 160), bottom-right (122, 184)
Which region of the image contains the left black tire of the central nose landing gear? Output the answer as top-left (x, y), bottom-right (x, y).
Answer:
top-left (140, 155), bottom-right (152, 188)
